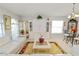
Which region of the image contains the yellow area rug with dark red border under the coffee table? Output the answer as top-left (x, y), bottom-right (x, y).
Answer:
top-left (19, 42), bottom-right (66, 54)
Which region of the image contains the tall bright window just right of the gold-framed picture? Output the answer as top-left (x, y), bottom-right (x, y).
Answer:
top-left (11, 19), bottom-right (19, 40)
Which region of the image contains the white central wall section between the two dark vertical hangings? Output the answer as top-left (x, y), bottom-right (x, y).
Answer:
top-left (29, 19), bottom-right (49, 39)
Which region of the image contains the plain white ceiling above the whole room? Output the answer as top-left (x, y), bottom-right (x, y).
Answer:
top-left (0, 3), bottom-right (79, 17)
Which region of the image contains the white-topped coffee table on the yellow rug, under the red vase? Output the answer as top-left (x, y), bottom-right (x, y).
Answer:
top-left (33, 40), bottom-right (51, 52)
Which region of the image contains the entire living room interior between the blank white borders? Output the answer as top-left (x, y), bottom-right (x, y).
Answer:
top-left (0, 3), bottom-right (79, 56)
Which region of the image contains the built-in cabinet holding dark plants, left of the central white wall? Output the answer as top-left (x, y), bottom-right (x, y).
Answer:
top-left (19, 20), bottom-right (29, 36)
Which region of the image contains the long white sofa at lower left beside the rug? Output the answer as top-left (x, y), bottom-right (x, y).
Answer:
top-left (0, 37), bottom-right (26, 54)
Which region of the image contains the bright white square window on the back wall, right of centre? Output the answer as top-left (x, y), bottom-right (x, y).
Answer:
top-left (52, 20), bottom-right (63, 33)
